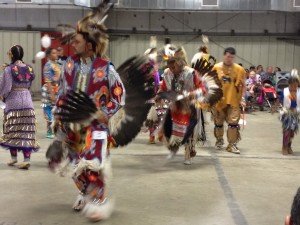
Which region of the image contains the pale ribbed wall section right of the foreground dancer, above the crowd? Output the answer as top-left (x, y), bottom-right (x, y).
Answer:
top-left (109, 35), bottom-right (300, 70)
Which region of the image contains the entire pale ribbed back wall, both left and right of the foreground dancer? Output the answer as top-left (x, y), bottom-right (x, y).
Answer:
top-left (0, 31), bottom-right (300, 96)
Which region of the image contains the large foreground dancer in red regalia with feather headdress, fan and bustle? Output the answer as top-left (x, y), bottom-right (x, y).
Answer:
top-left (46, 0), bottom-right (155, 221)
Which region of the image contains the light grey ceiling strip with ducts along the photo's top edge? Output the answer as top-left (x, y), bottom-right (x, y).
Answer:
top-left (0, 0), bottom-right (300, 12)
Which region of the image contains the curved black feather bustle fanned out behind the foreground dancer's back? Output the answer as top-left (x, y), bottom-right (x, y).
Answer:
top-left (112, 56), bottom-right (155, 146)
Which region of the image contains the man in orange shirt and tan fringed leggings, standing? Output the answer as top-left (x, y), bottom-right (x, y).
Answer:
top-left (214, 47), bottom-right (246, 154)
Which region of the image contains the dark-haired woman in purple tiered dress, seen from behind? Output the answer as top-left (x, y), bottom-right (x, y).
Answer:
top-left (0, 45), bottom-right (38, 169)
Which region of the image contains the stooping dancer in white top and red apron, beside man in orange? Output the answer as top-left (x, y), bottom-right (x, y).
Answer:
top-left (158, 45), bottom-right (222, 165)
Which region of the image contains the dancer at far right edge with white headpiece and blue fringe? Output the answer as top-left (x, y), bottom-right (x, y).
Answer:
top-left (280, 69), bottom-right (300, 155)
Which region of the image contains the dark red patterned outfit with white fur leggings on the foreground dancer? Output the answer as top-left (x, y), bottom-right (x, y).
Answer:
top-left (57, 56), bottom-right (125, 216)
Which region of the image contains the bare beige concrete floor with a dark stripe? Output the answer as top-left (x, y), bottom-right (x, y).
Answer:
top-left (0, 102), bottom-right (300, 225)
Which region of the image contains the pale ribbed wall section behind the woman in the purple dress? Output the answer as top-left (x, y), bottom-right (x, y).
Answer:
top-left (0, 31), bottom-right (41, 92)
